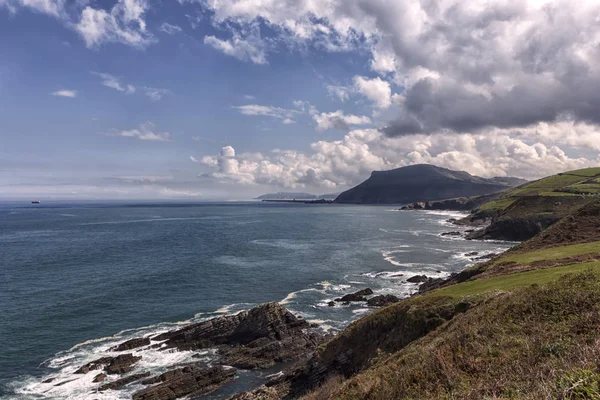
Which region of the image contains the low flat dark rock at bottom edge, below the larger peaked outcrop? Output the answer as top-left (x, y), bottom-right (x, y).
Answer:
top-left (133, 365), bottom-right (236, 400)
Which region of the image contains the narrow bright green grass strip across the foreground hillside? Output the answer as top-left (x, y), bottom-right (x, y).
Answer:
top-left (425, 261), bottom-right (600, 298)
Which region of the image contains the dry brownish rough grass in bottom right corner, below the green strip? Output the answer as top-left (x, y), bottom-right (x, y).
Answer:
top-left (305, 271), bottom-right (600, 400)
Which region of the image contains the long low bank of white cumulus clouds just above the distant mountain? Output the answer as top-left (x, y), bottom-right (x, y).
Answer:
top-left (200, 126), bottom-right (600, 189)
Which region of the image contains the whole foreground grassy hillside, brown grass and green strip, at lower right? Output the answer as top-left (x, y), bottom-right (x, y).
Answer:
top-left (307, 198), bottom-right (600, 399)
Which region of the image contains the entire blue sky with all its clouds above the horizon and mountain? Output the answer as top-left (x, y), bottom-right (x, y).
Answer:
top-left (0, 0), bottom-right (600, 200)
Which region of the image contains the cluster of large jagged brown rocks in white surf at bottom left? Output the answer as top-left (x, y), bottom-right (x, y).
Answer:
top-left (70, 304), bottom-right (328, 400)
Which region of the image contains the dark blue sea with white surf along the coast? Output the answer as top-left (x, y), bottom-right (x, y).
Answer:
top-left (0, 203), bottom-right (511, 400)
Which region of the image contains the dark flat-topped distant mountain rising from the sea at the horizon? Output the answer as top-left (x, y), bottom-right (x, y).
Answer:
top-left (335, 164), bottom-right (526, 204)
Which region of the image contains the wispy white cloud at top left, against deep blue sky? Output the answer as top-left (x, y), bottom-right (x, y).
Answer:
top-left (74, 0), bottom-right (156, 48)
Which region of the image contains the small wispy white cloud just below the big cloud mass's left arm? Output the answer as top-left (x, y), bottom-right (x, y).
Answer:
top-left (204, 28), bottom-right (267, 64)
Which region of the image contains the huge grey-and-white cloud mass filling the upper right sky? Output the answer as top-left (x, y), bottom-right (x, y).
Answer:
top-left (198, 0), bottom-right (600, 136)
